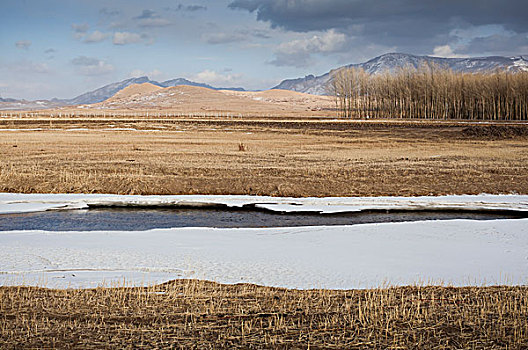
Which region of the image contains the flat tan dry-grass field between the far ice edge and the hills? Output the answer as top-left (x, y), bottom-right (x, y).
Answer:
top-left (0, 117), bottom-right (528, 197)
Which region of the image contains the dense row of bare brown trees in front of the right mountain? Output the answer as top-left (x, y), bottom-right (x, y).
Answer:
top-left (329, 65), bottom-right (528, 120)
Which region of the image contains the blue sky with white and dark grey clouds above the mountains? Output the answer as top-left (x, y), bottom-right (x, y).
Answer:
top-left (0, 0), bottom-right (528, 99)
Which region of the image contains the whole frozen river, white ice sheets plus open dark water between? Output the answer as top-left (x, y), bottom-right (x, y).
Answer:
top-left (0, 194), bottom-right (528, 289)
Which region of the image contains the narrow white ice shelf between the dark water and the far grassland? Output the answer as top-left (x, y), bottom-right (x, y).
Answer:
top-left (0, 193), bottom-right (528, 214)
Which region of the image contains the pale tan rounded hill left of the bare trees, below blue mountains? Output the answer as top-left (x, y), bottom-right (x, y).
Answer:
top-left (0, 83), bottom-right (337, 118)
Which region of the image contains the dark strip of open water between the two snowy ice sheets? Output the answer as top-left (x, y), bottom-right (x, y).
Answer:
top-left (0, 206), bottom-right (528, 231)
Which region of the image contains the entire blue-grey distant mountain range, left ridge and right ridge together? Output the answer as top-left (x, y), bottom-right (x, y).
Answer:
top-left (0, 53), bottom-right (528, 109)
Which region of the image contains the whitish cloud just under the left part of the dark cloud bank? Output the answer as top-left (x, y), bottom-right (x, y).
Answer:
top-left (271, 29), bottom-right (347, 67)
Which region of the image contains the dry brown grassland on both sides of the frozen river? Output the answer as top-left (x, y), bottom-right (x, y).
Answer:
top-left (0, 117), bottom-right (528, 349)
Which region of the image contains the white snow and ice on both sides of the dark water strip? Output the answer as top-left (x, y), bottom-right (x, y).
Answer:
top-left (0, 194), bottom-right (528, 289)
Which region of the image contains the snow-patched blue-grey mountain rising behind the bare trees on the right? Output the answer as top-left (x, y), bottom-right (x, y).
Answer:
top-left (274, 53), bottom-right (528, 95)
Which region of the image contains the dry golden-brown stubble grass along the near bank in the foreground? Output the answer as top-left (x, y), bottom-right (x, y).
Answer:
top-left (0, 280), bottom-right (528, 349)
